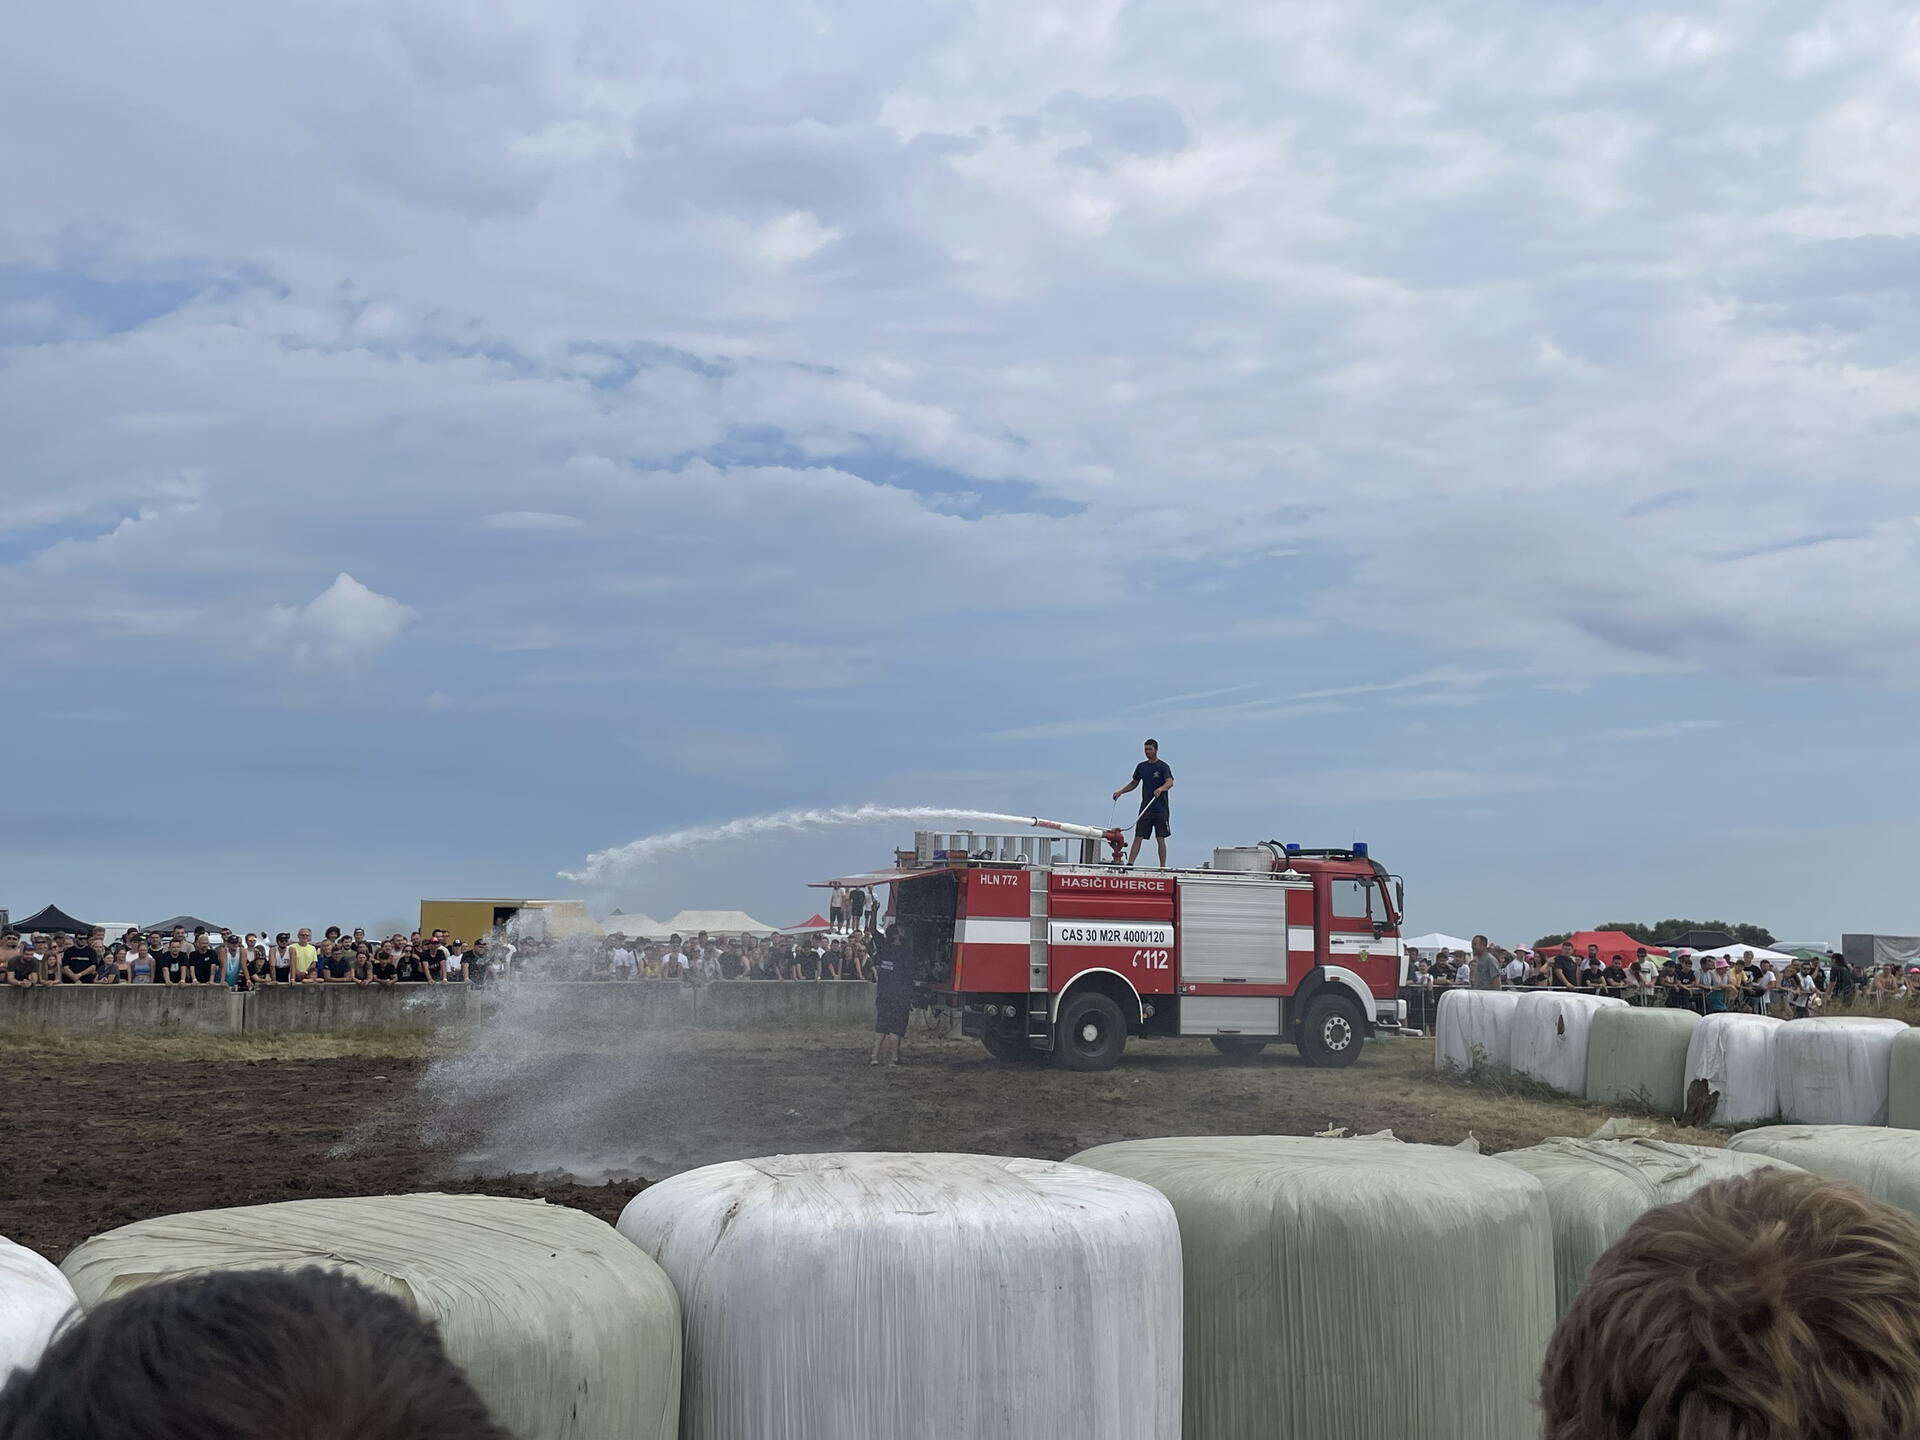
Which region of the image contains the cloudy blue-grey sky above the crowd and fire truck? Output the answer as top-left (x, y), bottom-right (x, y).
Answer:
top-left (0, 0), bottom-right (1920, 943)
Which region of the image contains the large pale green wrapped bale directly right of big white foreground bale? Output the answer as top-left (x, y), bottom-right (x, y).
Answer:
top-left (1075, 1135), bottom-right (1553, 1440)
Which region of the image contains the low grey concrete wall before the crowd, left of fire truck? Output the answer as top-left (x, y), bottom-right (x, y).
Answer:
top-left (0, 979), bottom-right (874, 1035)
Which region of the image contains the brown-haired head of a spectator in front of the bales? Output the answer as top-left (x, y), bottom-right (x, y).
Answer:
top-left (1542, 1169), bottom-right (1920, 1440)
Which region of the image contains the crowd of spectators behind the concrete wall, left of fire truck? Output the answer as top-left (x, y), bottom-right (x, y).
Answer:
top-left (0, 925), bottom-right (874, 991)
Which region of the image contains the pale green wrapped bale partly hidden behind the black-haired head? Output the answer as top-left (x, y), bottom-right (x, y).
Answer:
top-left (61, 1194), bottom-right (680, 1440)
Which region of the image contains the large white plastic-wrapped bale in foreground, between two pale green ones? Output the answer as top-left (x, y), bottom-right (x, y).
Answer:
top-left (620, 1154), bottom-right (1181, 1440)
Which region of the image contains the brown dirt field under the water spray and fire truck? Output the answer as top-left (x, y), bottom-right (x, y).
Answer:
top-left (0, 1033), bottom-right (1716, 1260)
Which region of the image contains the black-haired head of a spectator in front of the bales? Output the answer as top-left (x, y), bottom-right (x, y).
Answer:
top-left (0, 1269), bottom-right (511, 1440)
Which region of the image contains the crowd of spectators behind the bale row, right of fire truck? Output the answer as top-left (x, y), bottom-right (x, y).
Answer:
top-left (1407, 935), bottom-right (1920, 1029)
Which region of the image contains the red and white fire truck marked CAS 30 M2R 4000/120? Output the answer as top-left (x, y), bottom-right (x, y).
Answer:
top-left (824, 820), bottom-right (1405, 1069)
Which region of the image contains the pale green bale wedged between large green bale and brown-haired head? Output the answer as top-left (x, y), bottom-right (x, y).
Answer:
top-left (1494, 1139), bottom-right (1793, 1315)
